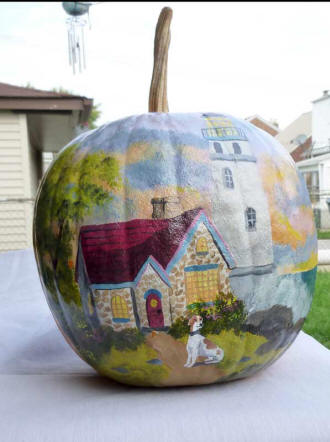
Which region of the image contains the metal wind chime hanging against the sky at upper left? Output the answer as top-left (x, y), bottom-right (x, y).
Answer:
top-left (62, 2), bottom-right (99, 74)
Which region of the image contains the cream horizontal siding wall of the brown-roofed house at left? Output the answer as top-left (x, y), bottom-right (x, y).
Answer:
top-left (0, 112), bottom-right (36, 251)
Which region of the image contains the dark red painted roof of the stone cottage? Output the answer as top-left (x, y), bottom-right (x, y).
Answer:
top-left (76, 208), bottom-right (202, 284)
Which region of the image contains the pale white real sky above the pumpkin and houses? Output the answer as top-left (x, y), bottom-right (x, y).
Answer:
top-left (0, 2), bottom-right (330, 129)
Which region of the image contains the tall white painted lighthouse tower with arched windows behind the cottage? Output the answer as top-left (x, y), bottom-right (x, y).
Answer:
top-left (202, 114), bottom-right (273, 274)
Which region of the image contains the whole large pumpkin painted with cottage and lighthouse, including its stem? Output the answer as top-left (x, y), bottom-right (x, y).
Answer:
top-left (34, 8), bottom-right (317, 386)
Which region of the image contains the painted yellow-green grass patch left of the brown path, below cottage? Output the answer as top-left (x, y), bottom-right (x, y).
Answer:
top-left (97, 344), bottom-right (170, 387)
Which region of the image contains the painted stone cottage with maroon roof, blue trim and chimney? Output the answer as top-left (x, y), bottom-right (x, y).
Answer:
top-left (76, 205), bottom-right (236, 330)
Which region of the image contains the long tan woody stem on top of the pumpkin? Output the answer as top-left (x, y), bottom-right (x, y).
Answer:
top-left (149, 7), bottom-right (173, 112)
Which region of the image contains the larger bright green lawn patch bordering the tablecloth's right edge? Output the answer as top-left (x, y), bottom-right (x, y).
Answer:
top-left (303, 272), bottom-right (330, 349)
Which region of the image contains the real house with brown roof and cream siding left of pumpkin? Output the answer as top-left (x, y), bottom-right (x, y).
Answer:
top-left (0, 83), bottom-right (93, 251)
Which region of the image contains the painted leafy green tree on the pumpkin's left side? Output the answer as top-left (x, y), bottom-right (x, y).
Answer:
top-left (35, 145), bottom-right (122, 304)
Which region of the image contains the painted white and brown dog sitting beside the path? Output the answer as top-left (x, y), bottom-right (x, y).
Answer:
top-left (184, 315), bottom-right (224, 367)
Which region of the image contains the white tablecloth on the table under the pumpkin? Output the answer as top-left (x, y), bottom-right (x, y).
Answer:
top-left (0, 250), bottom-right (330, 442)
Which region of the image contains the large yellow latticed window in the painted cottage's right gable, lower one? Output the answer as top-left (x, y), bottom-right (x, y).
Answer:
top-left (185, 264), bottom-right (219, 305)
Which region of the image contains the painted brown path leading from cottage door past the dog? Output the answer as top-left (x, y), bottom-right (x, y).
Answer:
top-left (146, 332), bottom-right (224, 386)
